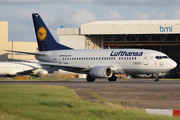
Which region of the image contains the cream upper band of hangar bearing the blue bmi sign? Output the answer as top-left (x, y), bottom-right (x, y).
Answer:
top-left (81, 20), bottom-right (180, 35)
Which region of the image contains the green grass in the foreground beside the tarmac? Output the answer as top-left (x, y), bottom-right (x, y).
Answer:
top-left (0, 85), bottom-right (178, 120)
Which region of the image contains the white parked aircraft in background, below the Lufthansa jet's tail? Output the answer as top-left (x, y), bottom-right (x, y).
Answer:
top-left (0, 62), bottom-right (58, 76)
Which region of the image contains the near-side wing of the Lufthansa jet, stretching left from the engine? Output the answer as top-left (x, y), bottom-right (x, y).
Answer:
top-left (32, 62), bottom-right (90, 69)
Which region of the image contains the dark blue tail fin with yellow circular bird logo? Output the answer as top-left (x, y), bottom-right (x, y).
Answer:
top-left (32, 13), bottom-right (72, 51)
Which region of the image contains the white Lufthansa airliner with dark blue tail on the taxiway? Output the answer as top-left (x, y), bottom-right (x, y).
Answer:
top-left (7, 13), bottom-right (177, 82)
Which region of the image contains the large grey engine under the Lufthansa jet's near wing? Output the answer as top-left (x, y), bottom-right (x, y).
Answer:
top-left (89, 66), bottom-right (113, 78)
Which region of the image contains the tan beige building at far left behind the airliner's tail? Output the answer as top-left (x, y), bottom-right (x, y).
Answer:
top-left (0, 21), bottom-right (37, 61)
